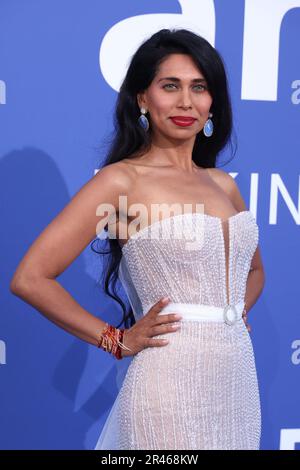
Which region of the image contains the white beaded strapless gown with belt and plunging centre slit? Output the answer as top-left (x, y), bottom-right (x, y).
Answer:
top-left (95, 210), bottom-right (261, 450)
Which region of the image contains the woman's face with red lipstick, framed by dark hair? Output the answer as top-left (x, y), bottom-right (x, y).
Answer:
top-left (138, 54), bottom-right (212, 139)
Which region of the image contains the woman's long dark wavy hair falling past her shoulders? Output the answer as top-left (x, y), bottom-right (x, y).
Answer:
top-left (91, 29), bottom-right (236, 328)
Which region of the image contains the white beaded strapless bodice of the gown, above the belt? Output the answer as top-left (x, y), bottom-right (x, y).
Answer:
top-left (120, 211), bottom-right (258, 318)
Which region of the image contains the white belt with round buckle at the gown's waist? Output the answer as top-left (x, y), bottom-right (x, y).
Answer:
top-left (159, 301), bottom-right (245, 325)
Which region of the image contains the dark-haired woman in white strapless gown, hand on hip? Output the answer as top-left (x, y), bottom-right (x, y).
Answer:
top-left (11, 29), bottom-right (264, 449)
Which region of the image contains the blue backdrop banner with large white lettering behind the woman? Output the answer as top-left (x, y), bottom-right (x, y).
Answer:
top-left (0, 0), bottom-right (300, 450)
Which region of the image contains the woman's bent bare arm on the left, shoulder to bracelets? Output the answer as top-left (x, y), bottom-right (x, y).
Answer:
top-left (10, 164), bottom-right (131, 345)
